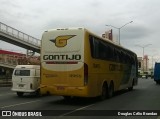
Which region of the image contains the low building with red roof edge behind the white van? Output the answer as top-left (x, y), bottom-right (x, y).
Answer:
top-left (0, 50), bottom-right (40, 79)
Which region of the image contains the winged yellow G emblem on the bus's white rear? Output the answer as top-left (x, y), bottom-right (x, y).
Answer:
top-left (50, 35), bottom-right (76, 47)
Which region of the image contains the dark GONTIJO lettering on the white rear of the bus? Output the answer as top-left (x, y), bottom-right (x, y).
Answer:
top-left (43, 54), bottom-right (81, 60)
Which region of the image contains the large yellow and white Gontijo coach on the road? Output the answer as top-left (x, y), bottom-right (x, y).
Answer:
top-left (41, 28), bottom-right (138, 99)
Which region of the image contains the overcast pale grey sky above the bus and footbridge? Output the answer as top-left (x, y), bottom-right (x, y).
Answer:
top-left (0, 0), bottom-right (160, 66)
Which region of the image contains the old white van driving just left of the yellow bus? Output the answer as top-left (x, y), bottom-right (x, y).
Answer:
top-left (11, 65), bottom-right (40, 96)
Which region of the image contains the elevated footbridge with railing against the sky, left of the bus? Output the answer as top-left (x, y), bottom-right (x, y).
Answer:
top-left (0, 22), bottom-right (41, 53)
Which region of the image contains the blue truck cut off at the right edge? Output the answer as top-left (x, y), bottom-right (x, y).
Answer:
top-left (154, 62), bottom-right (160, 84)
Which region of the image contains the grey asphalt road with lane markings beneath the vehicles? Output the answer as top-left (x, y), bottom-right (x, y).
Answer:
top-left (0, 79), bottom-right (160, 119)
